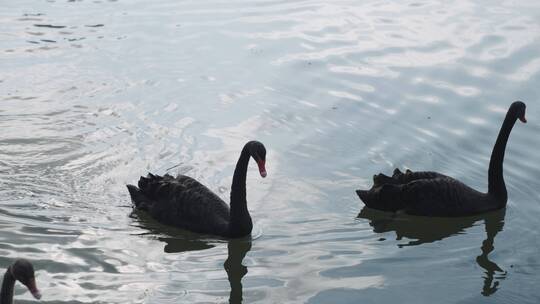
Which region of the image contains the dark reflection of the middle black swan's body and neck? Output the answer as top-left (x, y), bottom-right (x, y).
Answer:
top-left (132, 211), bottom-right (251, 304)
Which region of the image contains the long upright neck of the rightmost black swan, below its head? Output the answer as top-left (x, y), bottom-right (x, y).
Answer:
top-left (488, 111), bottom-right (517, 203)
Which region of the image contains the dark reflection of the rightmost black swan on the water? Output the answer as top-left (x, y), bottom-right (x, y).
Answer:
top-left (358, 207), bottom-right (506, 296)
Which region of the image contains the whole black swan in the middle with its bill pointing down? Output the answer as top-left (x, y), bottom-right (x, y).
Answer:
top-left (127, 141), bottom-right (266, 238)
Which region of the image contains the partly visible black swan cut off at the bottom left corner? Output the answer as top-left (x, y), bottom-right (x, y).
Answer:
top-left (0, 259), bottom-right (41, 304)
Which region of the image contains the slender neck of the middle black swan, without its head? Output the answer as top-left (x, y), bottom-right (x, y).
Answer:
top-left (229, 147), bottom-right (253, 237)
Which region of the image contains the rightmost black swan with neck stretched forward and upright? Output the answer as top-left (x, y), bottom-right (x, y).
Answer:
top-left (356, 101), bottom-right (527, 217)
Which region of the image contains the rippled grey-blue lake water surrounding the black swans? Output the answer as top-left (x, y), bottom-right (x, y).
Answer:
top-left (0, 0), bottom-right (540, 304)
